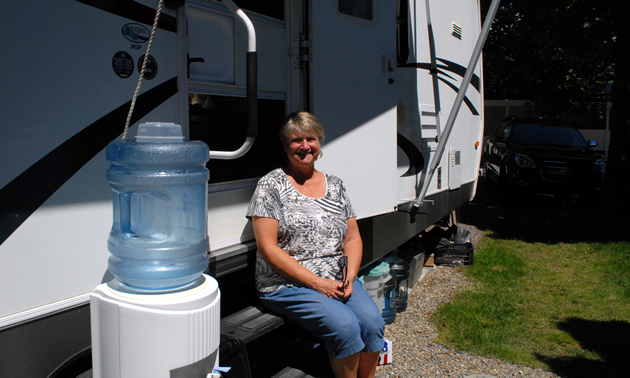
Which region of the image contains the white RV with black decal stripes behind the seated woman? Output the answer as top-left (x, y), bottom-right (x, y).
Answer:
top-left (0, 0), bottom-right (494, 377)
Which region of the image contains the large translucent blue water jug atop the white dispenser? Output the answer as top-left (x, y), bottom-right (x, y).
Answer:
top-left (107, 123), bottom-right (210, 291)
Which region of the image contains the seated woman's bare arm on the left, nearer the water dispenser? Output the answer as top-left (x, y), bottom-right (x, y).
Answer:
top-left (252, 217), bottom-right (346, 299)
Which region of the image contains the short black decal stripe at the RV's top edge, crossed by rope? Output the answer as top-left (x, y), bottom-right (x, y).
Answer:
top-left (77, 0), bottom-right (177, 33)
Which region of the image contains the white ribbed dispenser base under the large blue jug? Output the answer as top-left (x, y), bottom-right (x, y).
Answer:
top-left (90, 275), bottom-right (221, 378)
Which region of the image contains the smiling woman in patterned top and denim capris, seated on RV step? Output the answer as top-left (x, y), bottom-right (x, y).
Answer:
top-left (247, 112), bottom-right (384, 377)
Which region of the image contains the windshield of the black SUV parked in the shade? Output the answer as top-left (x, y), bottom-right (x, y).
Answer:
top-left (512, 124), bottom-right (588, 148)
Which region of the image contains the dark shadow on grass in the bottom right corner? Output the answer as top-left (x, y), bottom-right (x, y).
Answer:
top-left (535, 318), bottom-right (630, 377)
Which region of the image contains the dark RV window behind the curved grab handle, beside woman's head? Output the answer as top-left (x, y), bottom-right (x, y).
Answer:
top-left (189, 94), bottom-right (285, 184)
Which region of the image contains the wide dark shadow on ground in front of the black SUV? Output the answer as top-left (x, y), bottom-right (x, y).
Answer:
top-left (458, 183), bottom-right (630, 243)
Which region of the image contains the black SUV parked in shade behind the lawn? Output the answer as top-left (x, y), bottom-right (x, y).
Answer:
top-left (482, 118), bottom-right (606, 200)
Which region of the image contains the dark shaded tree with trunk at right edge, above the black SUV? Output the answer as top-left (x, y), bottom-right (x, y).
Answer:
top-left (481, 0), bottom-right (630, 207)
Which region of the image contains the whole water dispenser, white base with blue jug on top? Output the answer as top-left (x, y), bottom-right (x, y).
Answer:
top-left (90, 123), bottom-right (221, 378)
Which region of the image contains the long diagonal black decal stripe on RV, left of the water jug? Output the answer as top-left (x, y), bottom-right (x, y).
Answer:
top-left (0, 77), bottom-right (177, 244)
